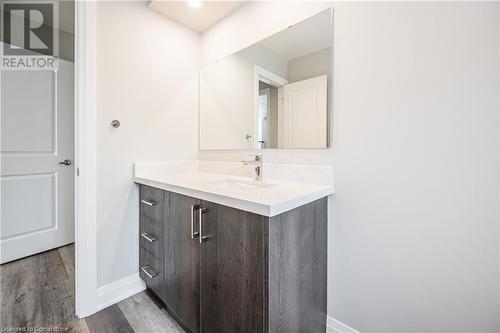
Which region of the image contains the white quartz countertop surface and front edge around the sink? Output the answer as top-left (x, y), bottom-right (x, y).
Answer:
top-left (134, 173), bottom-right (333, 217)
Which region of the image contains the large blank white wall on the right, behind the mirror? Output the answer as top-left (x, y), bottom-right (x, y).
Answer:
top-left (199, 2), bottom-right (500, 332)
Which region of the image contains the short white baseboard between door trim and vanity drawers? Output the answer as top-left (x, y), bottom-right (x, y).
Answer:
top-left (97, 273), bottom-right (146, 311)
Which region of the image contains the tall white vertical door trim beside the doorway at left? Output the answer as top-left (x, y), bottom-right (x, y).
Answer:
top-left (75, 1), bottom-right (97, 318)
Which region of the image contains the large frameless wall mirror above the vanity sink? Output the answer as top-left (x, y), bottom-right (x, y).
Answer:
top-left (199, 9), bottom-right (333, 150)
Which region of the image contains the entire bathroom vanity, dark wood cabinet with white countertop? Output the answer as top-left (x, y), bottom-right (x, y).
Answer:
top-left (135, 160), bottom-right (333, 332)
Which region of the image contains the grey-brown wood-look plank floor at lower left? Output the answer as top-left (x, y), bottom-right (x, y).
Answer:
top-left (0, 245), bottom-right (184, 333)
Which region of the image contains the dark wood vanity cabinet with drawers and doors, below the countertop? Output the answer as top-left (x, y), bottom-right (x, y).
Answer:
top-left (140, 185), bottom-right (327, 333)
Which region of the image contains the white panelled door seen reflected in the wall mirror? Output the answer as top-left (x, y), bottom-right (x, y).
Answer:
top-left (281, 75), bottom-right (328, 148)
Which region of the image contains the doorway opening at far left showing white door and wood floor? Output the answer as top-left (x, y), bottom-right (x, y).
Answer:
top-left (0, 0), bottom-right (78, 328)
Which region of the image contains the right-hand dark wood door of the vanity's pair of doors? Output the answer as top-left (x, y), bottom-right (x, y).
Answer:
top-left (200, 202), bottom-right (268, 333)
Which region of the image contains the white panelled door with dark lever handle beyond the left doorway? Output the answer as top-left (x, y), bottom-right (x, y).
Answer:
top-left (0, 59), bottom-right (75, 263)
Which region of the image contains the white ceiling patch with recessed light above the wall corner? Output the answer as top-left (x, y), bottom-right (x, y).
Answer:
top-left (149, 0), bottom-right (246, 32)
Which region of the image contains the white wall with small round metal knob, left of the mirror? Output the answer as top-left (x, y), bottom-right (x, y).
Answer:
top-left (97, 1), bottom-right (200, 286)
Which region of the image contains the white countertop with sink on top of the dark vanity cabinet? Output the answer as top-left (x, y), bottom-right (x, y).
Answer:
top-left (134, 162), bottom-right (333, 217)
